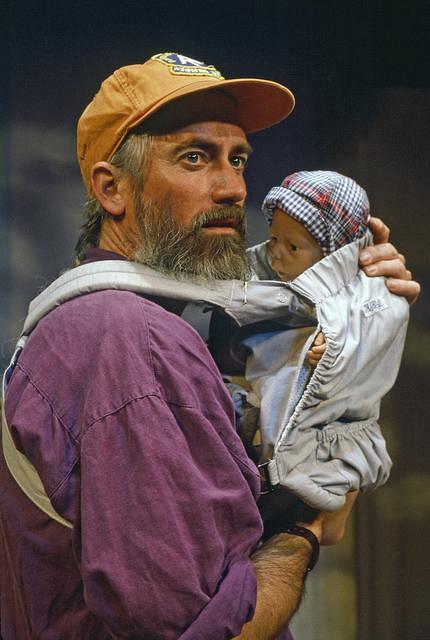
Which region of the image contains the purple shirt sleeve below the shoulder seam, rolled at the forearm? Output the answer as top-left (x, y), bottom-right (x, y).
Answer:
top-left (74, 395), bottom-right (261, 640)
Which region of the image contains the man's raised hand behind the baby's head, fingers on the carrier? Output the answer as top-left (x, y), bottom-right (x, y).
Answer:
top-left (359, 218), bottom-right (421, 304)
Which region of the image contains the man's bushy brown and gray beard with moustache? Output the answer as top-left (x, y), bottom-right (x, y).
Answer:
top-left (134, 198), bottom-right (250, 280)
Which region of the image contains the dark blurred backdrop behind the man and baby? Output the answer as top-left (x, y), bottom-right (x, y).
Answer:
top-left (0, 0), bottom-right (430, 640)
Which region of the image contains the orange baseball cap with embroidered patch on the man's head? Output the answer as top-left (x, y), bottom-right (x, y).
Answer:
top-left (77, 53), bottom-right (294, 193)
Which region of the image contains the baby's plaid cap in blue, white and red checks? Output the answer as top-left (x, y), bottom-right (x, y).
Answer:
top-left (262, 171), bottom-right (369, 255)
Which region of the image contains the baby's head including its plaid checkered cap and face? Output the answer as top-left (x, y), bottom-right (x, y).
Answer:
top-left (262, 171), bottom-right (369, 281)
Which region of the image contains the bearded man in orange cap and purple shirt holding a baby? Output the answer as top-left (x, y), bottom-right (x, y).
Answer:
top-left (0, 54), bottom-right (418, 640)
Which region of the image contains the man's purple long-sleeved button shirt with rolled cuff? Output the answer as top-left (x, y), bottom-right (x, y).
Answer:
top-left (0, 252), bottom-right (289, 640)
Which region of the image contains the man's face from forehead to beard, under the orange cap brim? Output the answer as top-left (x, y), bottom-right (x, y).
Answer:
top-left (131, 122), bottom-right (251, 279)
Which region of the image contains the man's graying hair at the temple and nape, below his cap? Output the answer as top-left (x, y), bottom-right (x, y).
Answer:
top-left (75, 129), bottom-right (153, 263)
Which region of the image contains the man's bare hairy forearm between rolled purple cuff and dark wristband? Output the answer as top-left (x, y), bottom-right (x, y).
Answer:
top-left (236, 533), bottom-right (312, 640)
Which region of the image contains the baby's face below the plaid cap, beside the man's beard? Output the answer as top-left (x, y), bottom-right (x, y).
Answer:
top-left (268, 209), bottom-right (324, 282)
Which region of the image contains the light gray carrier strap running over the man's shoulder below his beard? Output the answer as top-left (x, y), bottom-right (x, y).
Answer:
top-left (22, 260), bottom-right (313, 335)
